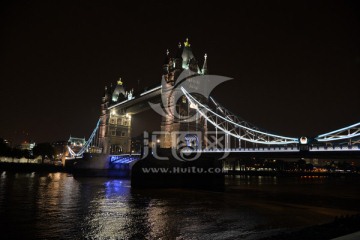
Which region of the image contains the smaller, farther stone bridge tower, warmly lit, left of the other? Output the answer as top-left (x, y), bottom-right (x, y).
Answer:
top-left (98, 79), bottom-right (132, 154)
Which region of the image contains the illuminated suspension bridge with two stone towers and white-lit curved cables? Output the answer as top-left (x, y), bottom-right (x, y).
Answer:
top-left (67, 40), bottom-right (360, 161)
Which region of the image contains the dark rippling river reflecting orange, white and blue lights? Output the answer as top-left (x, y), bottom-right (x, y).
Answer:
top-left (0, 171), bottom-right (360, 239)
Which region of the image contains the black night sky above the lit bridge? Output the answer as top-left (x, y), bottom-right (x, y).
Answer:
top-left (0, 0), bottom-right (360, 142)
